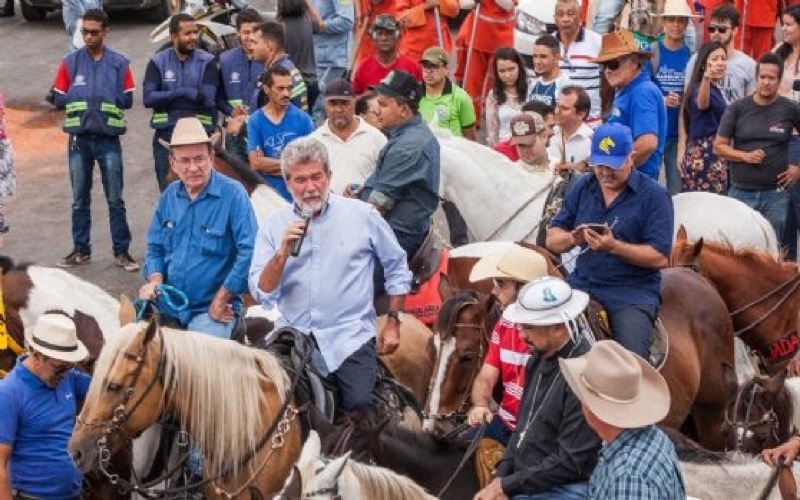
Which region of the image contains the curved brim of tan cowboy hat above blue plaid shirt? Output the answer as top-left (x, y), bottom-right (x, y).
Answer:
top-left (558, 356), bottom-right (670, 429)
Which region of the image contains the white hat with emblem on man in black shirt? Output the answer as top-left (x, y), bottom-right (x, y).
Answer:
top-left (503, 276), bottom-right (589, 326)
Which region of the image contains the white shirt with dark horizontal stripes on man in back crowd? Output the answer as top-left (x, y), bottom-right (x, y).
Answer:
top-left (553, 28), bottom-right (603, 128)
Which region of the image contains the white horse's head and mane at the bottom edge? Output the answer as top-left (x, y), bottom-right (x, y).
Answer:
top-left (275, 430), bottom-right (436, 500)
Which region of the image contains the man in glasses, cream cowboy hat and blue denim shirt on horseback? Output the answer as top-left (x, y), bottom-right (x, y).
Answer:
top-left (139, 118), bottom-right (257, 338)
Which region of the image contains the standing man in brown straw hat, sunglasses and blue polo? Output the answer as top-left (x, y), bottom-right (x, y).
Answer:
top-left (594, 29), bottom-right (667, 180)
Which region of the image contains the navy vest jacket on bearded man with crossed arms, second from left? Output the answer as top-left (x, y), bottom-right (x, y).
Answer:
top-left (144, 47), bottom-right (219, 133)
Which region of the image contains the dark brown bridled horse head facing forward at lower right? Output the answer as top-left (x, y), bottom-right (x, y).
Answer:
top-left (722, 365), bottom-right (792, 454)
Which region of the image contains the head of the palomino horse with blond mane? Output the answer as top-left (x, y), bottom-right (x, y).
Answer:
top-left (69, 320), bottom-right (164, 472)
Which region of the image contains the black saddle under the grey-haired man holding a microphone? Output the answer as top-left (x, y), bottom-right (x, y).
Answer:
top-left (255, 327), bottom-right (422, 422)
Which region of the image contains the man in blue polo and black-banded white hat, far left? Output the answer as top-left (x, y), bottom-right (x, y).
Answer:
top-left (0, 314), bottom-right (90, 499)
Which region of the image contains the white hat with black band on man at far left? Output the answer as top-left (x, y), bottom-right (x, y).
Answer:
top-left (25, 314), bottom-right (89, 363)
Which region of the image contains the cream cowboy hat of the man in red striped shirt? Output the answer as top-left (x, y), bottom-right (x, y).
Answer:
top-left (469, 244), bottom-right (547, 283)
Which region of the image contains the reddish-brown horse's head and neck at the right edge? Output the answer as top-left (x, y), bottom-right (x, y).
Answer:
top-left (671, 227), bottom-right (800, 375)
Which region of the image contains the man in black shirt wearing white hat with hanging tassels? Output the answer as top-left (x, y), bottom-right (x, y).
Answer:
top-left (475, 276), bottom-right (600, 500)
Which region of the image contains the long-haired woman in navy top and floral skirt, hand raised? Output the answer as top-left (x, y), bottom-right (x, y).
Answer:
top-left (678, 42), bottom-right (728, 194)
